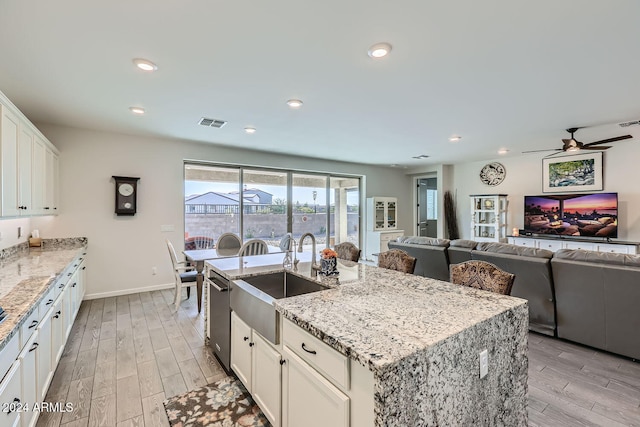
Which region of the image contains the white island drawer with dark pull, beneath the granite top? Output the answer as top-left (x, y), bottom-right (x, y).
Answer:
top-left (282, 319), bottom-right (349, 390)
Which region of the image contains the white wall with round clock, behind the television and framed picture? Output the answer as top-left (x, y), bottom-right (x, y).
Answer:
top-left (453, 140), bottom-right (640, 242)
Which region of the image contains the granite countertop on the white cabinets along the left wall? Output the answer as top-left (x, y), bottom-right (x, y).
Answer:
top-left (0, 238), bottom-right (87, 350)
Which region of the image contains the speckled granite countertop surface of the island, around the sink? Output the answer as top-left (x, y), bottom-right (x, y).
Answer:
top-left (206, 253), bottom-right (526, 372)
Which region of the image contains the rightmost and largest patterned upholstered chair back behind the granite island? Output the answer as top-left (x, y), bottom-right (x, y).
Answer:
top-left (449, 260), bottom-right (516, 295)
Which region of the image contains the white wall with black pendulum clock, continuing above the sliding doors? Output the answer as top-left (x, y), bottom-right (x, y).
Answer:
top-left (26, 124), bottom-right (412, 296)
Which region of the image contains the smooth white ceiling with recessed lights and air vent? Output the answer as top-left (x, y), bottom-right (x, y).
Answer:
top-left (0, 0), bottom-right (640, 167)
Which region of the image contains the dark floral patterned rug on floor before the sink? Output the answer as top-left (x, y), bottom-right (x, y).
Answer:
top-left (164, 377), bottom-right (271, 427)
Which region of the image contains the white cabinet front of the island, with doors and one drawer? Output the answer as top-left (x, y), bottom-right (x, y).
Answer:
top-left (231, 312), bottom-right (375, 427)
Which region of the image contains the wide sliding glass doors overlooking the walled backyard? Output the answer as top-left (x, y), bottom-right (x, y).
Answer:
top-left (184, 163), bottom-right (361, 249)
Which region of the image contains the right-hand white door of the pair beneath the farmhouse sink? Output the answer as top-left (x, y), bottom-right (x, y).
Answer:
top-left (251, 331), bottom-right (282, 427)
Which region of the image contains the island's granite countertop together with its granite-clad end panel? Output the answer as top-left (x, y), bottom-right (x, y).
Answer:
top-left (207, 254), bottom-right (528, 426)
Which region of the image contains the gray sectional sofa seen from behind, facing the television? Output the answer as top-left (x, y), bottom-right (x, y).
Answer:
top-left (389, 237), bottom-right (640, 359)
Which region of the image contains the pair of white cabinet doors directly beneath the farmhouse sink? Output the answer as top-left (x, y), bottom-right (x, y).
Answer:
top-left (231, 312), bottom-right (282, 427)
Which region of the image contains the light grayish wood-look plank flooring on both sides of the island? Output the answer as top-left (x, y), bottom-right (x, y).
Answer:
top-left (38, 290), bottom-right (640, 427)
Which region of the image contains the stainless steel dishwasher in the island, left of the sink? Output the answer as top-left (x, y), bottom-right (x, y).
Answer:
top-left (205, 270), bottom-right (231, 372)
